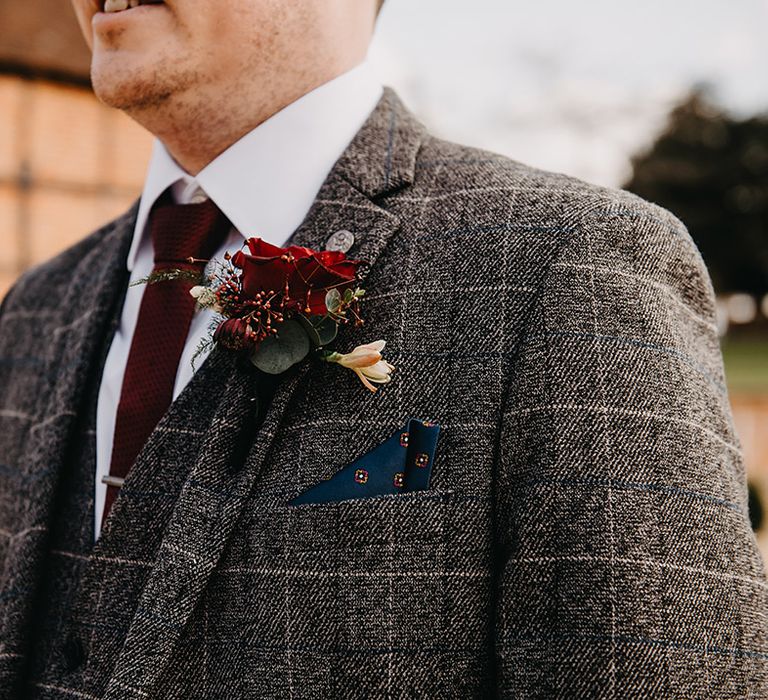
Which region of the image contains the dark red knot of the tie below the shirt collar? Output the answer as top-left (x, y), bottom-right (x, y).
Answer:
top-left (150, 198), bottom-right (231, 267)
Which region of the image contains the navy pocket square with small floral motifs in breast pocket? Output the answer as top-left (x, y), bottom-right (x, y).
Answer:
top-left (289, 418), bottom-right (440, 506)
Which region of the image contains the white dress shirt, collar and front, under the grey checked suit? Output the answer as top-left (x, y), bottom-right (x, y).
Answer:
top-left (94, 63), bottom-right (382, 539)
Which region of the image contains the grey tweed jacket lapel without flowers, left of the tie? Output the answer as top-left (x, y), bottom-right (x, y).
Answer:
top-left (0, 206), bottom-right (137, 687)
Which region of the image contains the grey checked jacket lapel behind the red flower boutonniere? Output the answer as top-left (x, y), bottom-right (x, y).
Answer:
top-left (104, 89), bottom-right (424, 700)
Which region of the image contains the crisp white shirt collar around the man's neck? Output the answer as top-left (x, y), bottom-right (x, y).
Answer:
top-left (126, 62), bottom-right (390, 271)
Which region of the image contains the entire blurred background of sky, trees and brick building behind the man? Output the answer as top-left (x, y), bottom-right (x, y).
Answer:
top-left (0, 0), bottom-right (768, 561)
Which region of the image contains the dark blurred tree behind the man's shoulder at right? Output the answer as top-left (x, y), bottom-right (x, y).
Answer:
top-left (625, 88), bottom-right (768, 296)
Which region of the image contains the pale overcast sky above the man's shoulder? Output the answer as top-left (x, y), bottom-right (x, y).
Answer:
top-left (370, 0), bottom-right (768, 185)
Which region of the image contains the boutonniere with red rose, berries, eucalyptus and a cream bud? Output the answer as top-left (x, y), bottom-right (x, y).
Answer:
top-left (166, 238), bottom-right (395, 391)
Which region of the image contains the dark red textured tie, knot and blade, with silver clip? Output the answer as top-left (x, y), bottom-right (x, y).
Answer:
top-left (102, 193), bottom-right (231, 522)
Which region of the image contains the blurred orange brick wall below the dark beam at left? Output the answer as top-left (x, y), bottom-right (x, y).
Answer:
top-left (0, 75), bottom-right (151, 296)
